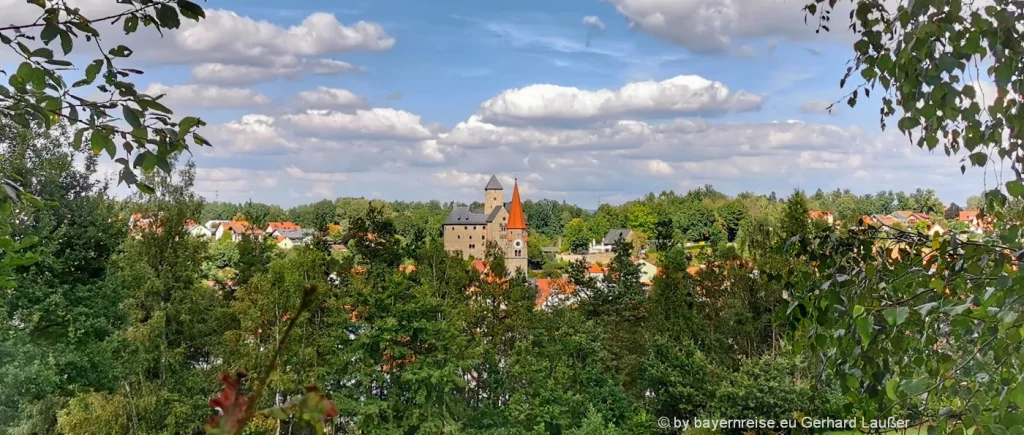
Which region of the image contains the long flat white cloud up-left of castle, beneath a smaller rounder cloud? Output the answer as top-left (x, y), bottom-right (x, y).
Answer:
top-left (282, 107), bottom-right (433, 140)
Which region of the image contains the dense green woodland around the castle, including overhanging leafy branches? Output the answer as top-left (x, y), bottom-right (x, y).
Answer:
top-left (0, 0), bottom-right (1024, 435)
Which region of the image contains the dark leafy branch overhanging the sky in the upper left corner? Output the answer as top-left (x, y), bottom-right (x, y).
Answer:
top-left (0, 0), bottom-right (210, 192)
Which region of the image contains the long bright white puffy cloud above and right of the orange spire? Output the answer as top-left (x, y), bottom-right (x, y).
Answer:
top-left (478, 76), bottom-right (764, 124)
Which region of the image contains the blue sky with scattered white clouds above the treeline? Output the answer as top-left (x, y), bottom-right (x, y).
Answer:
top-left (0, 0), bottom-right (1002, 209)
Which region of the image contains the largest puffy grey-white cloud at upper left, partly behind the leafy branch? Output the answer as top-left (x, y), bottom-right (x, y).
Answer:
top-left (0, 0), bottom-right (395, 85)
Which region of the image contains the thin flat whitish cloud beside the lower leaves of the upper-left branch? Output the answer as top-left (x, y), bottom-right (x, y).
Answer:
top-left (142, 83), bottom-right (270, 108)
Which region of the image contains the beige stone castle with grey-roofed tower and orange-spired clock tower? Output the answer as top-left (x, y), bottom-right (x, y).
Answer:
top-left (444, 175), bottom-right (527, 273)
